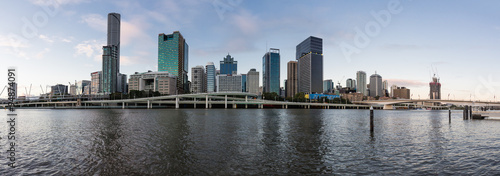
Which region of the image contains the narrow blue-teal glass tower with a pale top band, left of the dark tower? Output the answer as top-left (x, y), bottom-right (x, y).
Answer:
top-left (262, 48), bottom-right (280, 95)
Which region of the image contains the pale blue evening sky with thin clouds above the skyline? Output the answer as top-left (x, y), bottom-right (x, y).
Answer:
top-left (0, 0), bottom-right (500, 101)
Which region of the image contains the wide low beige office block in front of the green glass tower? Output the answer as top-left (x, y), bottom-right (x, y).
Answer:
top-left (128, 71), bottom-right (177, 95)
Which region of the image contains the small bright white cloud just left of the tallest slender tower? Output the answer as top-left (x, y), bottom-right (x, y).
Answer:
top-left (75, 40), bottom-right (105, 61)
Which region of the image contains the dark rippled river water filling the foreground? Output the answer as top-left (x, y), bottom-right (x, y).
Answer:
top-left (0, 109), bottom-right (500, 175)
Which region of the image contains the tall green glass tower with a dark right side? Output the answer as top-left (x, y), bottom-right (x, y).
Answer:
top-left (158, 31), bottom-right (189, 94)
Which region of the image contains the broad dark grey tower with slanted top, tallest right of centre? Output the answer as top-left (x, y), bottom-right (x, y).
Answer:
top-left (296, 36), bottom-right (323, 93)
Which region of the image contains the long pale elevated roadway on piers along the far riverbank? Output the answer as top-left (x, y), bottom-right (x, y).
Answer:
top-left (0, 92), bottom-right (376, 109)
